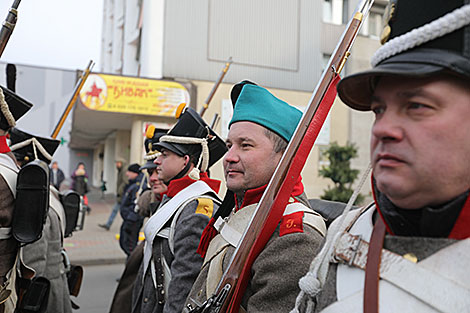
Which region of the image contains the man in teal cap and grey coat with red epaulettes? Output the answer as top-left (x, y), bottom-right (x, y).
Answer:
top-left (185, 81), bottom-right (326, 313)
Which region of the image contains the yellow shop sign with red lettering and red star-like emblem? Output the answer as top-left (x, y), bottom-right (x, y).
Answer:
top-left (80, 74), bottom-right (189, 117)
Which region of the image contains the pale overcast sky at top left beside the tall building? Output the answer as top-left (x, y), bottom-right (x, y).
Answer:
top-left (0, 0), bottom-right (103, 71)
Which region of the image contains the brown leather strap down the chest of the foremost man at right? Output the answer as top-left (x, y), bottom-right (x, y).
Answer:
top-left (364, 216), bottom-right (385, 313)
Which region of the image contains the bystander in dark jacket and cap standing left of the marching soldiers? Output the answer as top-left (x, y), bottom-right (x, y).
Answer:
top-left (119, 163), bottom-right (144, 256)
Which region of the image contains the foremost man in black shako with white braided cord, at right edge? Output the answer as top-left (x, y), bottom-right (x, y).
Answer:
top-left (293, 0), bottom-right (470, 313)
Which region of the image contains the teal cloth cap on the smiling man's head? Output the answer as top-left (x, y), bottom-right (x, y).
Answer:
top-left (228, 84), bottom-right (302, 141)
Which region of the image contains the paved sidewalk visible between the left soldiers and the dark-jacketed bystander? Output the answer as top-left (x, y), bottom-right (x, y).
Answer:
top-left (64, 189), bottom-right (126, 265)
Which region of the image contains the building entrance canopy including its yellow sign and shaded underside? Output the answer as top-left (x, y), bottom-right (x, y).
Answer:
top-left (69, 73), bottom-right (196, 148)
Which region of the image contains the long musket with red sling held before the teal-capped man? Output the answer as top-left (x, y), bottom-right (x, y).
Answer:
top-left (191, 0), bottom-right (373, 313)
